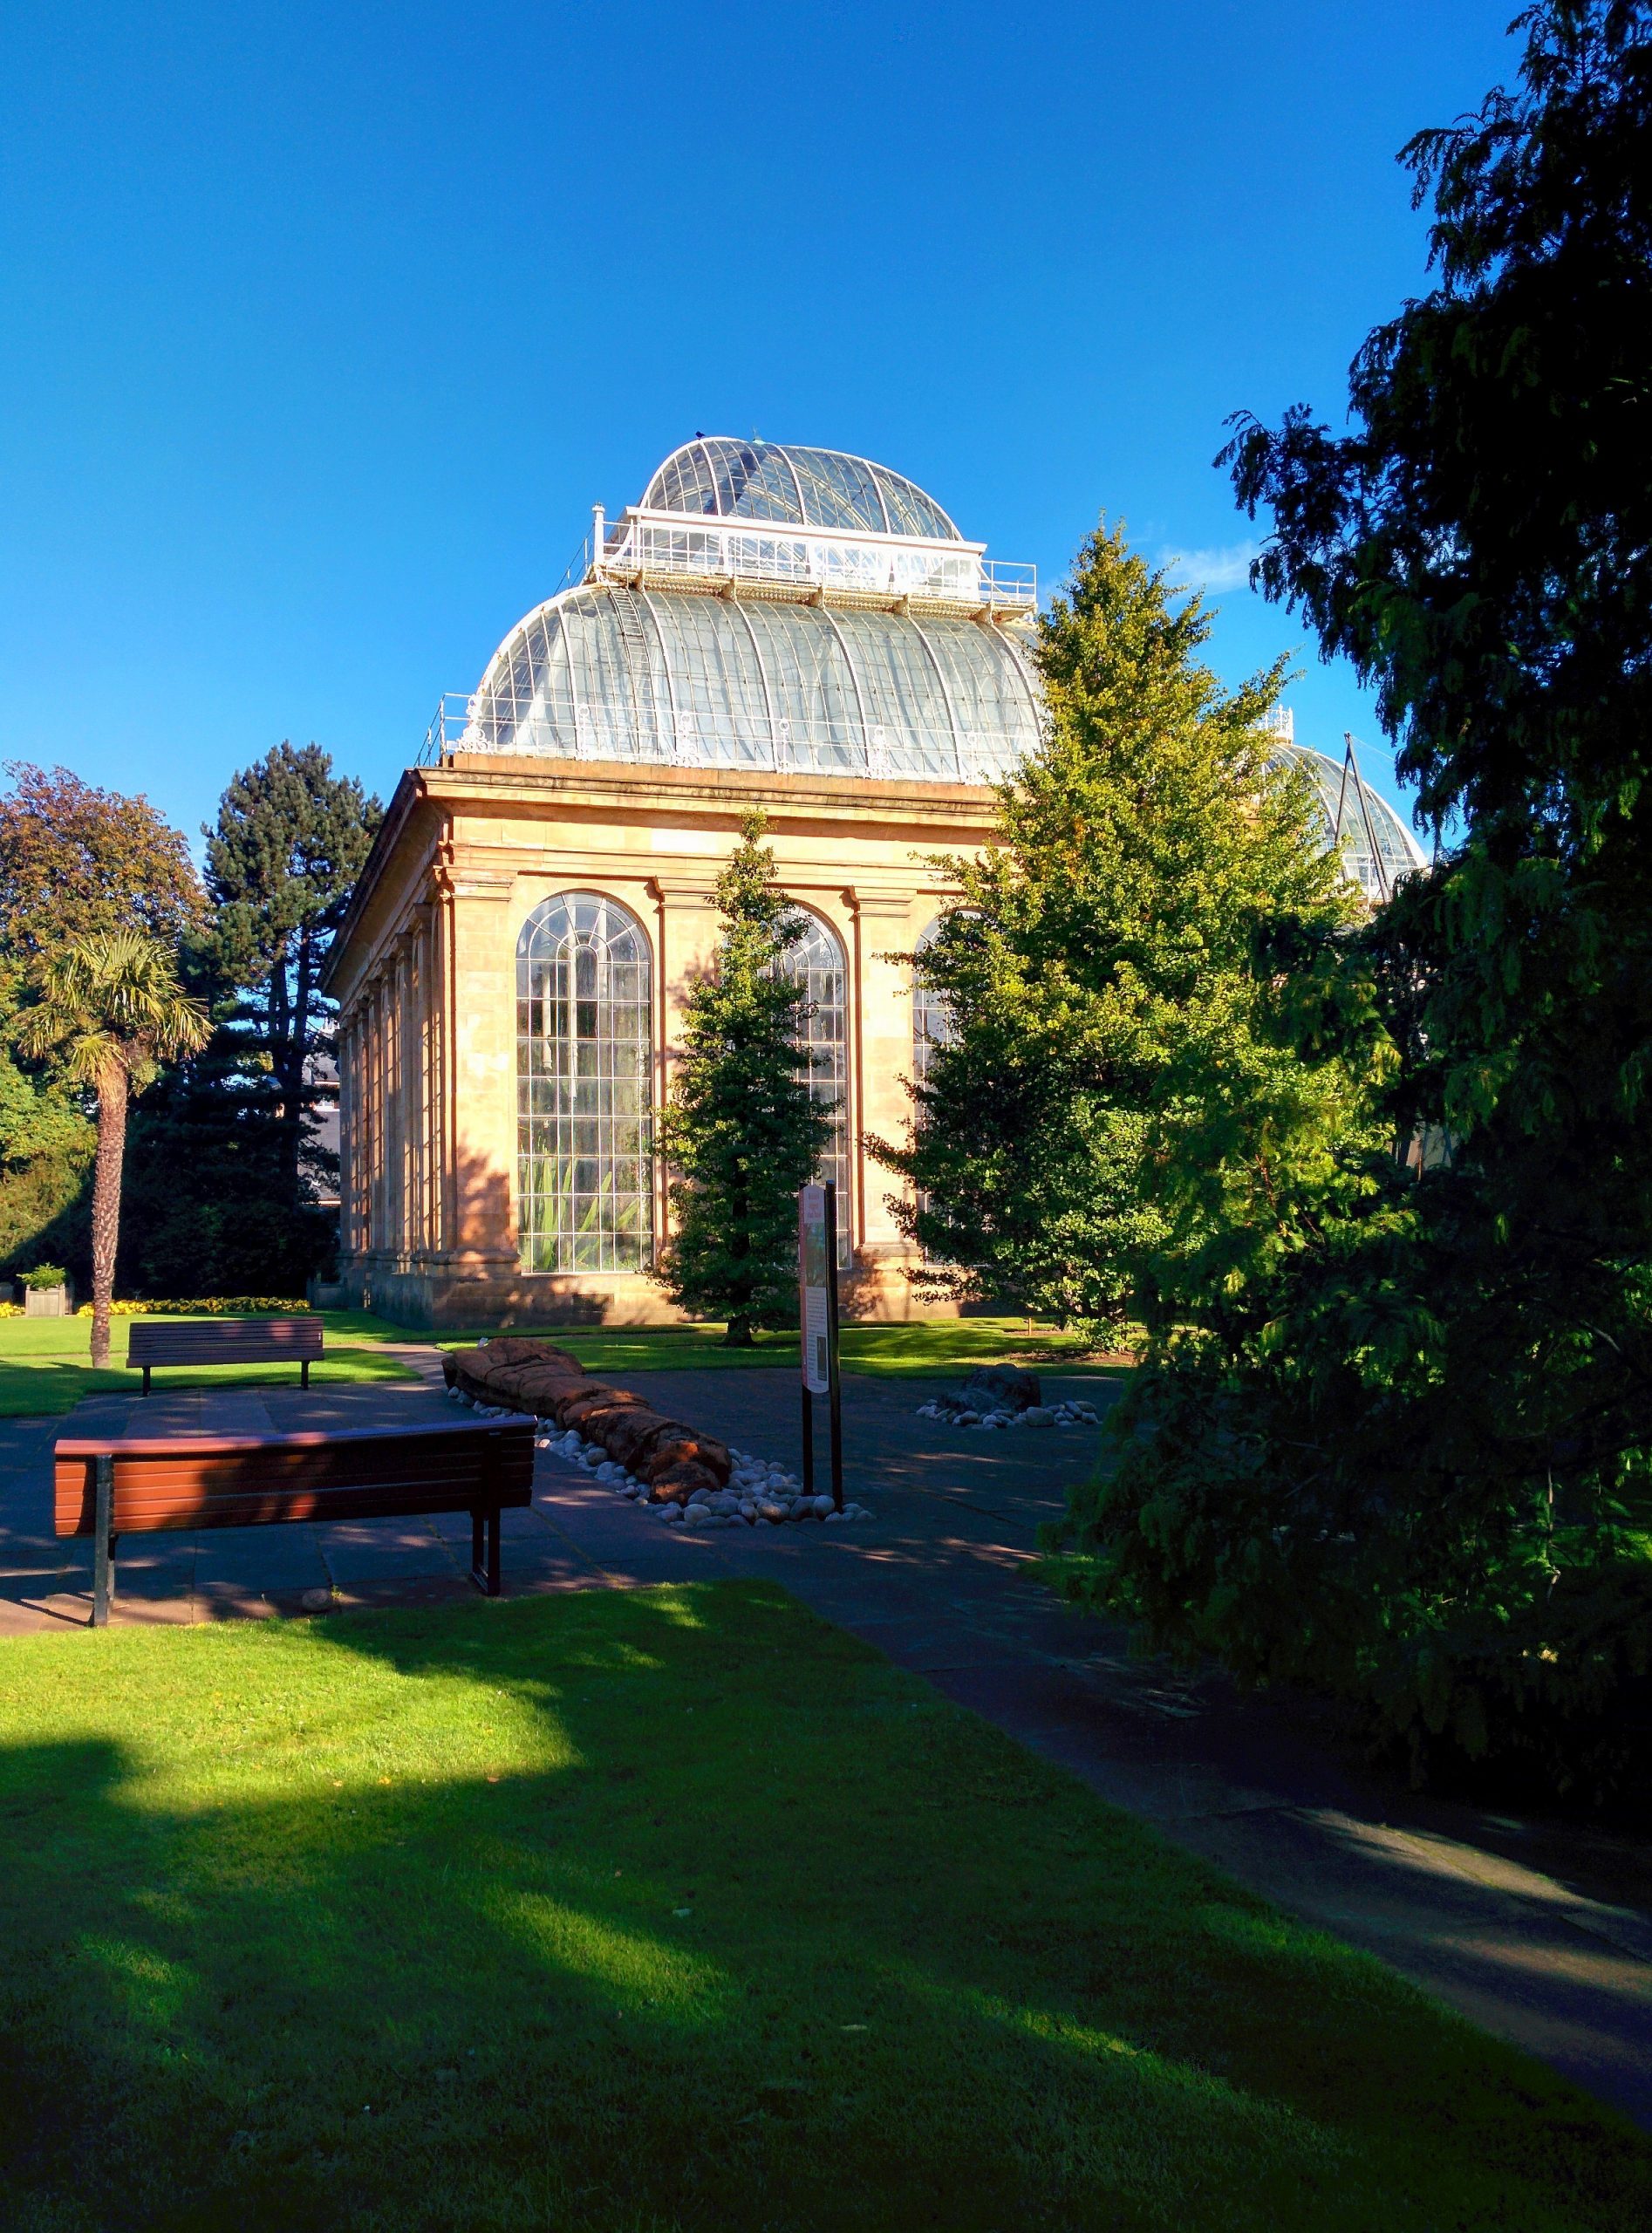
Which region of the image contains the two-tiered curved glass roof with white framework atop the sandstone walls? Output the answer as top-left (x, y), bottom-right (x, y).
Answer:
top-left (427, 438), bottom-right (1041, 784)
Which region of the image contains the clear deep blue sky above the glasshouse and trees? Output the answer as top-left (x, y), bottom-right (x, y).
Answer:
top-left (0, 0), bottom-right (1516, 833)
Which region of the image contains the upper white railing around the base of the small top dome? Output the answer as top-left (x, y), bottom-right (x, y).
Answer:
top-left (585, 507), bottom-right (1038, 614)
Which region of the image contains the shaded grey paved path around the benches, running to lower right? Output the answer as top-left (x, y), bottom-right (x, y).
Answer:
top-left (0, 1351), bottom-right (1652, 2128)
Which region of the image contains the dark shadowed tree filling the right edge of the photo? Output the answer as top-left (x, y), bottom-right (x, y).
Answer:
top-left (1065, 4), bottom-right (1652, 1804)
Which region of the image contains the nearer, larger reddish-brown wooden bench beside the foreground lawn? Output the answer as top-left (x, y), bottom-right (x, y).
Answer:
top-left (56, 1418), bottom-right (538, 1628)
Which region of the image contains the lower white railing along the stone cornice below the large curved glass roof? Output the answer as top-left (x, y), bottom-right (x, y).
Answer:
top-left (420, 690), bottom-right (1031, 784)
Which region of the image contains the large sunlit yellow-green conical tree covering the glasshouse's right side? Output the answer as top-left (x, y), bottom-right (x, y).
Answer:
top-left (877, 527), bottom-right (1348, 1327)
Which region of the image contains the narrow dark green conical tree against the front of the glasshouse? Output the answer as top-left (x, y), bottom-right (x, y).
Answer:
top-left (661, 815), bottom-right (833, 1349)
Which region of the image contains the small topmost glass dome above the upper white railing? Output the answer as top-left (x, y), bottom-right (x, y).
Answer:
top-left (641, 435), bottom-right (962, 543)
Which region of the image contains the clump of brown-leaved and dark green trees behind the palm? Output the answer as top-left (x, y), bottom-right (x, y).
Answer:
top-left (0, 743), bottom-right (379, 1293)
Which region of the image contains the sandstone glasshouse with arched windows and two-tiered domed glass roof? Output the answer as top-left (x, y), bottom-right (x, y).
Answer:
top-left (328, 435), bottom-right (1416, 1327)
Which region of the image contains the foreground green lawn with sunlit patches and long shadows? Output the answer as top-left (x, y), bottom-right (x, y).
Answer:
top-left (0, 1583), bottom-right (1652, 2233)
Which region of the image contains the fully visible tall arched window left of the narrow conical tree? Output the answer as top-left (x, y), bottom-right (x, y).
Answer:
top-left (515, 891), bottom-right (654, 1271)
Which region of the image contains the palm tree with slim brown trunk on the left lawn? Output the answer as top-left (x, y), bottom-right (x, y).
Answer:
top-left (17, 932), bottom-right (210, 1364)
